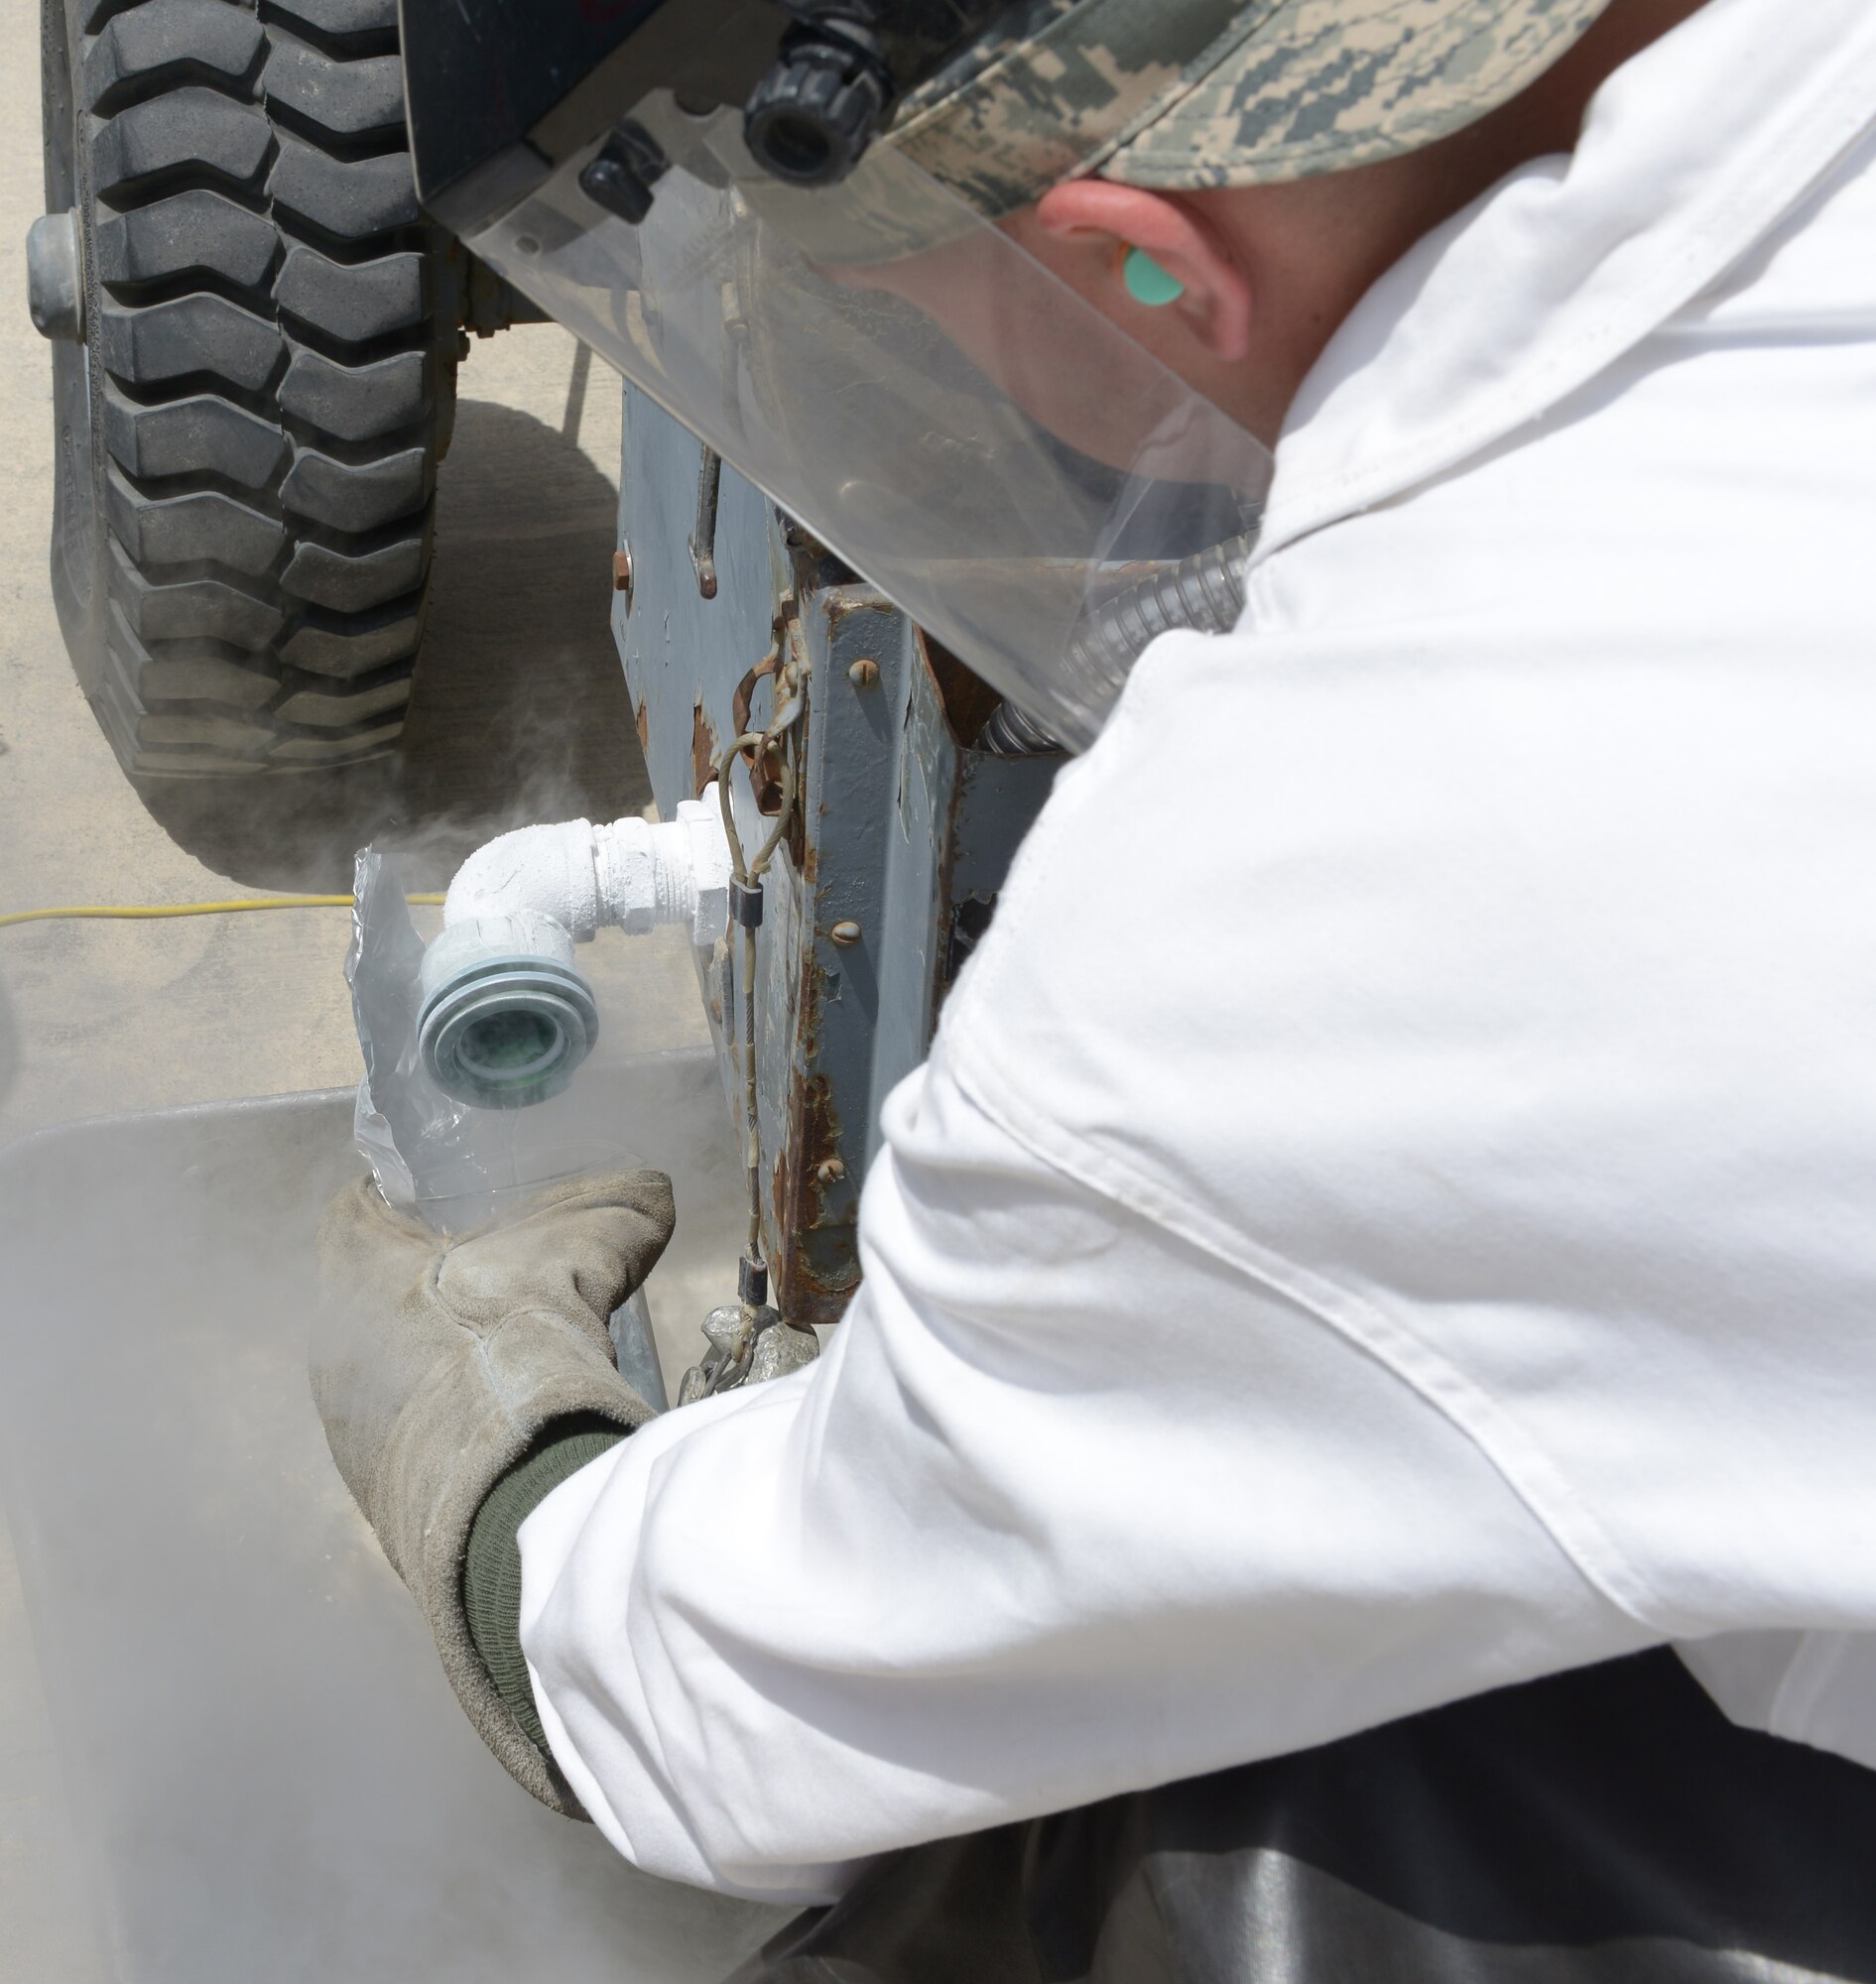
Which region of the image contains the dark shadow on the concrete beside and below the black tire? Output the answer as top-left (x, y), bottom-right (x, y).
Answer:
top-left (129, 399), bottom-right (651, 893)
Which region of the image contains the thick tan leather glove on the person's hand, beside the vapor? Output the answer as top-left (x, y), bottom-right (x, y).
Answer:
top-left (312, 1171), bottom-right (675, 1817)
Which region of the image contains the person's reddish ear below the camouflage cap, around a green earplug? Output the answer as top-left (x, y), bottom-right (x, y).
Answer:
top-left (1035, 179), bottom-right (1251, 361)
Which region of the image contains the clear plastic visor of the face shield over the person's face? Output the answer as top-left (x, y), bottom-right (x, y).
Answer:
top-left (468, 93), bottom-right (1271, 748)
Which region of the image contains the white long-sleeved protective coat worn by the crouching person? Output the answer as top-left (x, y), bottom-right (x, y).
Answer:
top-left (522, 0), bottom-right (1876, 1901)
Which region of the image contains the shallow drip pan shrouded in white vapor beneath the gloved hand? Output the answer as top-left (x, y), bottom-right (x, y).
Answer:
top-left (0, 1050), bottom-right (786, 1984)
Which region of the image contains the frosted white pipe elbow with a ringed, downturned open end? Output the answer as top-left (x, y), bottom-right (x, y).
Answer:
top-left (417, 790), bottom-right (730, 1109)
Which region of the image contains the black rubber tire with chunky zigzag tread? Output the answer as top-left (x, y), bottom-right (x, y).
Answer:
top-left (42, 0), bottom-right (458, 778)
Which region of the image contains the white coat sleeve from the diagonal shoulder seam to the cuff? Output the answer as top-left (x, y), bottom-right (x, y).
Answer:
top-left (522, 1061), bottom-right (1650, 1903)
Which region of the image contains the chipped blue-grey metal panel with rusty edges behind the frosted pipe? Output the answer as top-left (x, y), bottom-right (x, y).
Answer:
top-left (613, 389), bottom-right (1055, 1323)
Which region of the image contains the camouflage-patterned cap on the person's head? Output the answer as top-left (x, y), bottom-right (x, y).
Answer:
top-left (889, 0), bottom-right (1608, 218)
